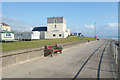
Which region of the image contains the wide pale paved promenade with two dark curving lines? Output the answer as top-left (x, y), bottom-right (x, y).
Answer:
top-left (2, 40), bottom-right (115, 78)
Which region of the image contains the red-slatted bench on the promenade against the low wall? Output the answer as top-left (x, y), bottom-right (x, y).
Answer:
top-left (44, 44), bottom-right (62, 57)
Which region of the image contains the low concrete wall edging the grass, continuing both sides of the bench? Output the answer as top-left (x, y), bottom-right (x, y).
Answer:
top-left (0, 40), bottom-right (94, 68)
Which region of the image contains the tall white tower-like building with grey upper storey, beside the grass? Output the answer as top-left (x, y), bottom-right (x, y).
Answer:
top-left (45, 17), bottom-right (70, 39)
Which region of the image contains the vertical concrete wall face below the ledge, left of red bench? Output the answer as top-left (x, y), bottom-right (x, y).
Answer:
top-left (2, 50), bottom-right (43, 68)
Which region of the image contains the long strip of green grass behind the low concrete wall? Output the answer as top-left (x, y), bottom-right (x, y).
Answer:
top-left (2, 37), bottom-right (95, 51)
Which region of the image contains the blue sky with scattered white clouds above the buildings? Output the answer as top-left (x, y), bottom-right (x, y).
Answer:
top-left (2, 2), bottom-right (118, 37)
